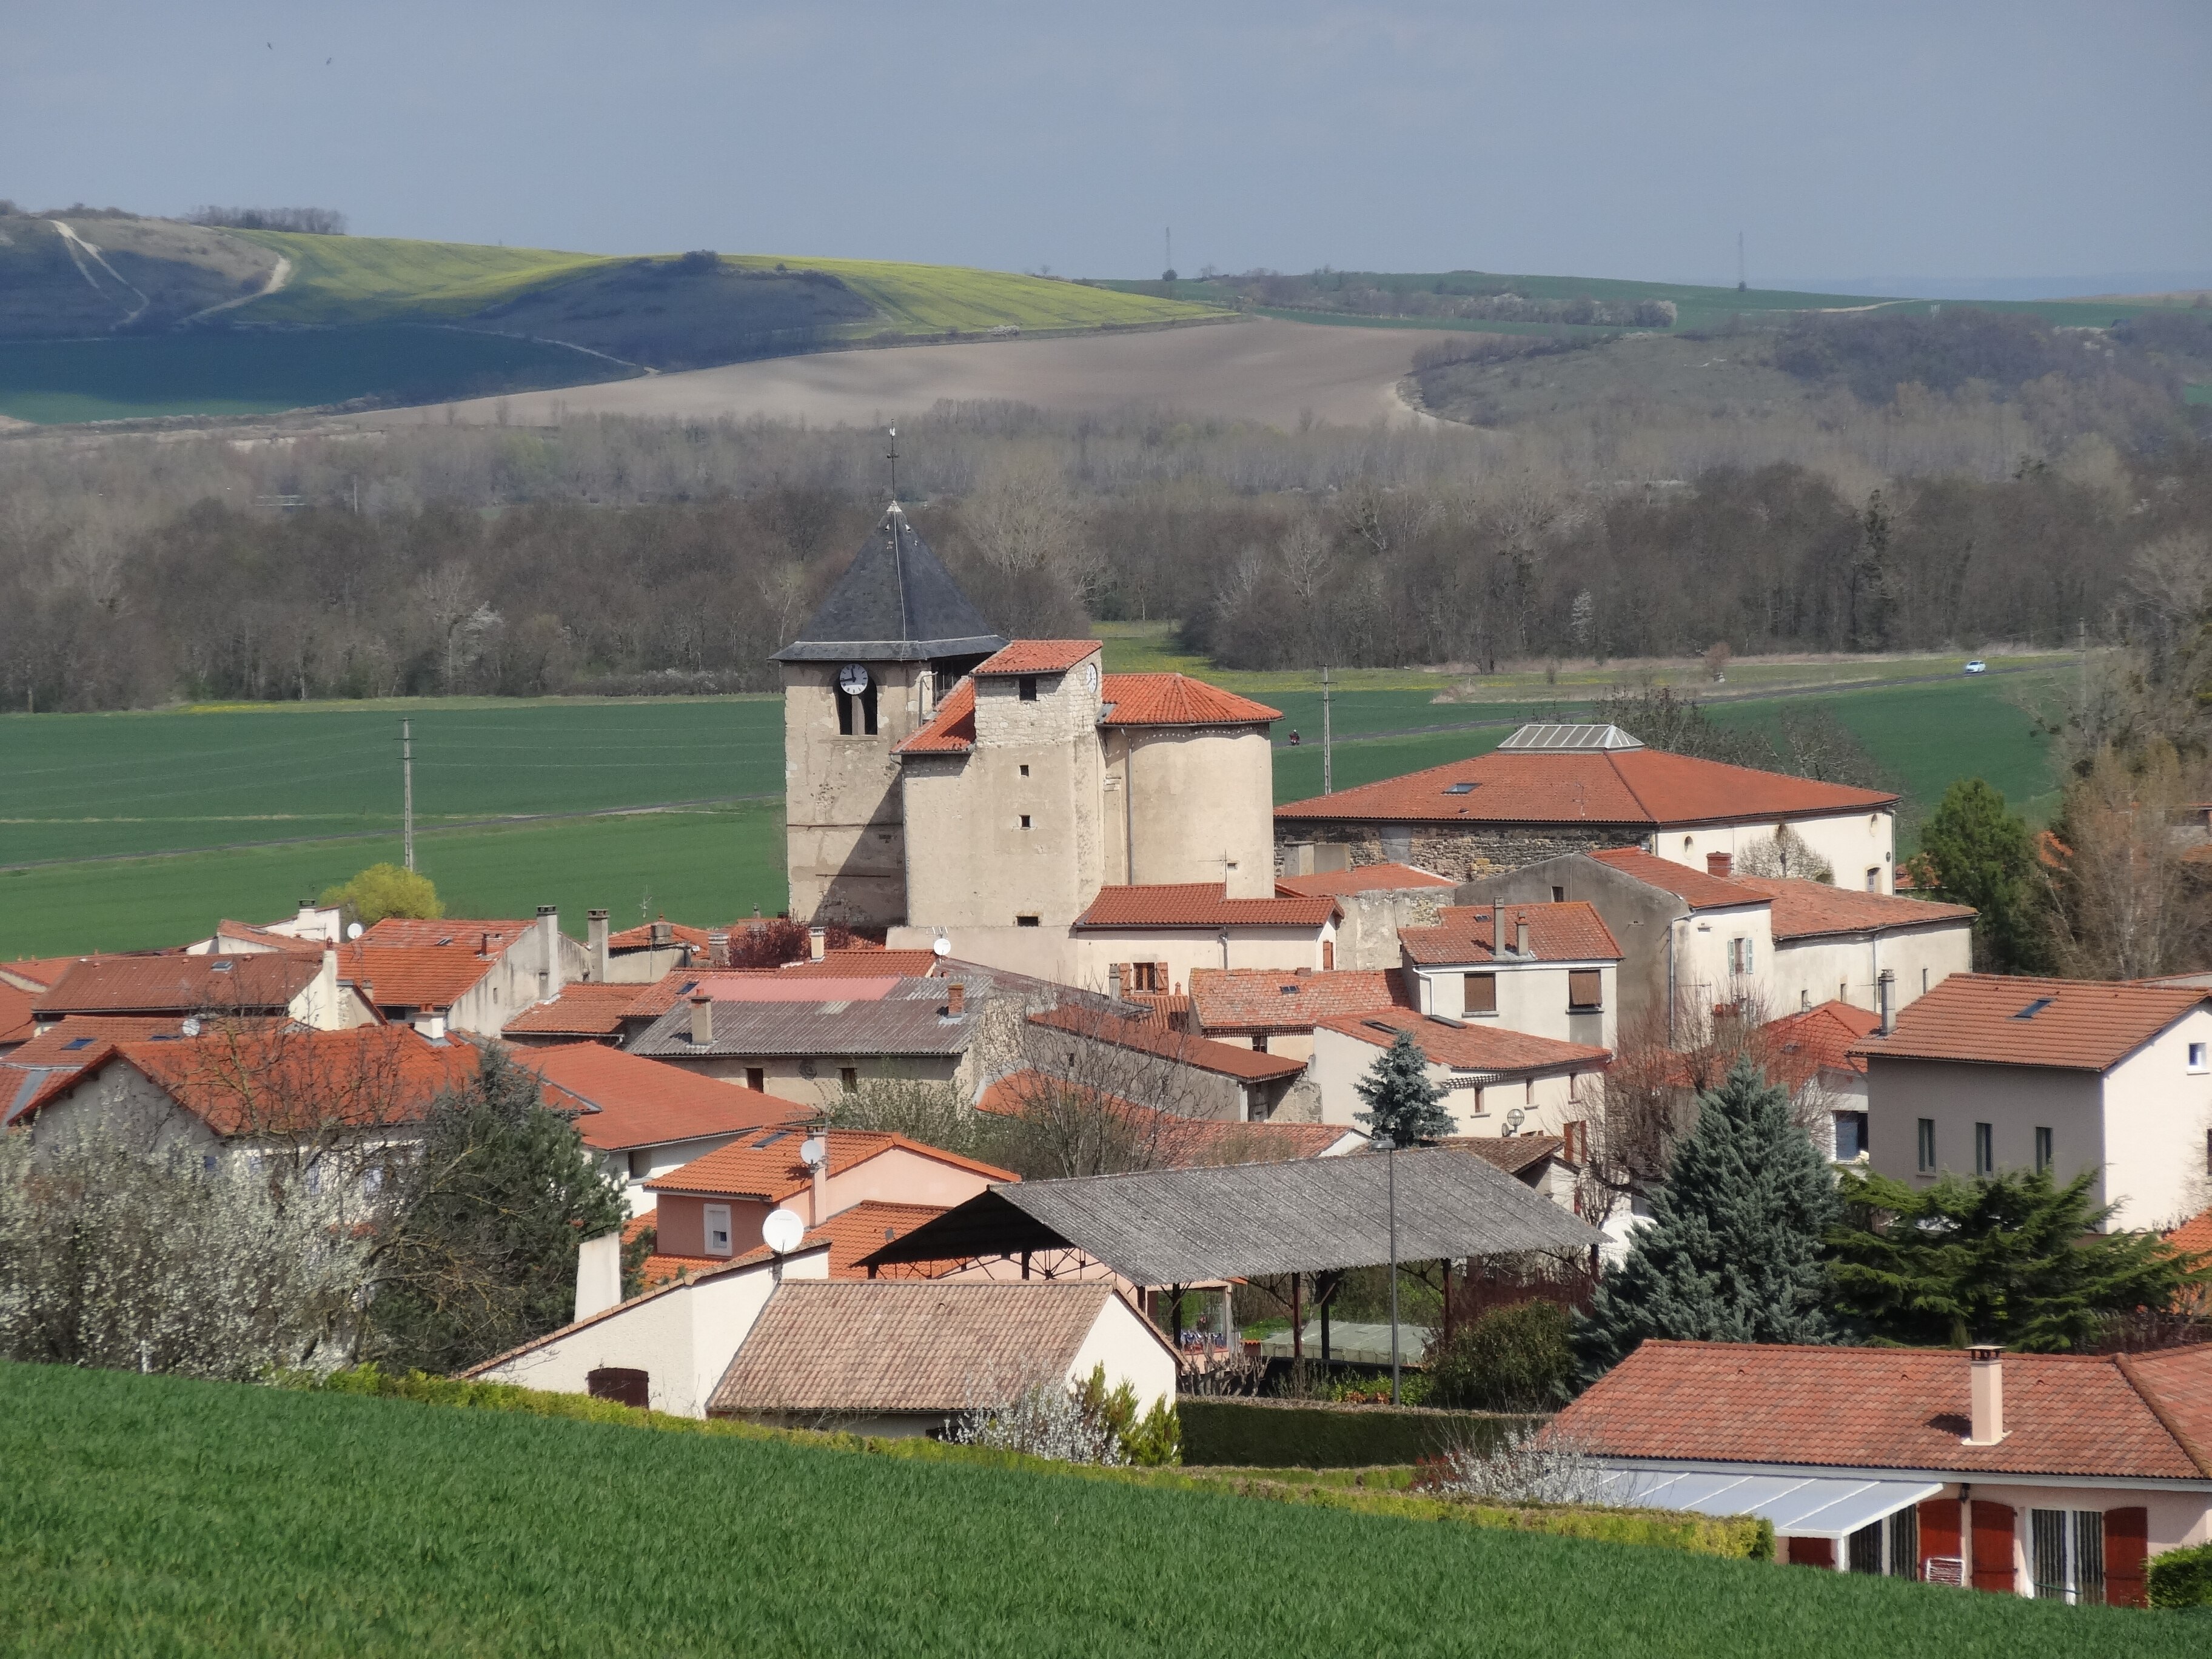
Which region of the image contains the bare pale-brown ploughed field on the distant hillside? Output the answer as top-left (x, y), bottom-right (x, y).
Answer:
top-left (352, 318), bottom-right (1455, 427)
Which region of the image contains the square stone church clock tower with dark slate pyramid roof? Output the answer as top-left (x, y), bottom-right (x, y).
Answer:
top-left (774, 500), bottom-right (1007, 927)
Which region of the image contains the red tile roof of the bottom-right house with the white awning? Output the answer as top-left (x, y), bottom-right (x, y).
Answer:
top-left (1553, 1341), bottom-right (2212, 1480)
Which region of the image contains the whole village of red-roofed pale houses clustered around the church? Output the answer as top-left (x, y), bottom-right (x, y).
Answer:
top-left (0, 502), bottom-right (2212, 1606)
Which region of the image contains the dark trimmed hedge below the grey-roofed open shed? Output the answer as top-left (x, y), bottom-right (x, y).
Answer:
top-left (1177, 1396), bottom-right (1542, 1469)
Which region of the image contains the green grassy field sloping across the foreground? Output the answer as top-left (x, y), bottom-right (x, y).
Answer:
top-left (0, 1367), bottom-right (2199, 1659)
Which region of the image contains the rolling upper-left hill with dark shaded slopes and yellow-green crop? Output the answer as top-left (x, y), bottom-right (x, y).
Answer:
top-left (0, 212), bottom-right (1223, 423)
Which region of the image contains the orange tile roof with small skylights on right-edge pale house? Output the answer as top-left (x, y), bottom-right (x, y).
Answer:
top-left (1851, 973), bottom-right (2212, 1071)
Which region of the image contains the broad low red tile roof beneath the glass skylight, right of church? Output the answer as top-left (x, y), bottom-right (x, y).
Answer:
top-left (1274, 750), bottom-right (1898, 830)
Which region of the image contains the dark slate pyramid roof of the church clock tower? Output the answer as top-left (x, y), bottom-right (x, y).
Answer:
top-left (774, 502), bottom-right (1007, 662)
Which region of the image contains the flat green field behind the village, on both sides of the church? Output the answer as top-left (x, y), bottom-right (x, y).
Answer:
top-left (0, 654), bottom-right (2071, 958)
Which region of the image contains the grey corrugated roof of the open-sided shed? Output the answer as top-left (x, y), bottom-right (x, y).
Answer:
top-left (854, 1148), bottom-right (1600, 1285)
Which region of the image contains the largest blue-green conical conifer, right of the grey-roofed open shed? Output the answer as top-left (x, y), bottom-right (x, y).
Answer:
top-left (1575, 1057), bottom-right (1838, 1380)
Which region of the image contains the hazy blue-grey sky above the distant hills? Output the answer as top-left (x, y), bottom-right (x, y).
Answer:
top-left (0, 0), bottom-right (2212, 292)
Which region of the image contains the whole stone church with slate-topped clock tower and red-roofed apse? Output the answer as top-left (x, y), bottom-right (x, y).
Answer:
top-left (776, 502), bottom-right (1338, 991)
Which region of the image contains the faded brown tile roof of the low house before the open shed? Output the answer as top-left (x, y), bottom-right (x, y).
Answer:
top-left (706, 1279), bottom-right (1115, 1416)
